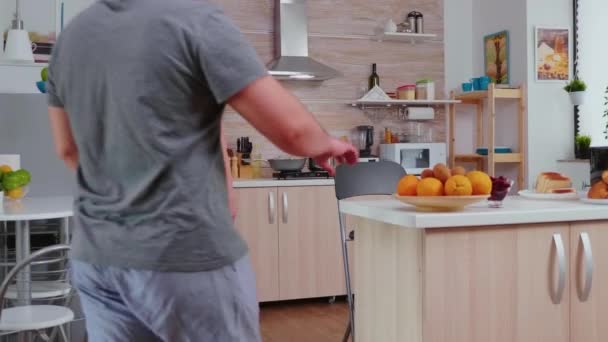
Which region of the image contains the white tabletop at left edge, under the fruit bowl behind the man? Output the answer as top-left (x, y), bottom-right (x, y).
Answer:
top-left (0, 196), bottom-right (74, 222)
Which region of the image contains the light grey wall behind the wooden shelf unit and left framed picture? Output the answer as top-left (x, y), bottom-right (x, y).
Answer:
top-left (445, 0), bottom-right (527, 184)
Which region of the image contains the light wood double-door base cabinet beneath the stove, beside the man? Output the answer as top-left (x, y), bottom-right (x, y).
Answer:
top-left (236, 186), bottom-right (346, 302)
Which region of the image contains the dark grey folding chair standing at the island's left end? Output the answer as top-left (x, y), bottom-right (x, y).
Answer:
top-left (335, 161), bottom-right (406, 342)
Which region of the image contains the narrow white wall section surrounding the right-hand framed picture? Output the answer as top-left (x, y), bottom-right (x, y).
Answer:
top-left (526, 0), bottom-right (572, 183)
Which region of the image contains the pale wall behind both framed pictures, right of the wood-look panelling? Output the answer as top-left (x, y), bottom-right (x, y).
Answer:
top-left (445, 0), bottom-right (572, 185)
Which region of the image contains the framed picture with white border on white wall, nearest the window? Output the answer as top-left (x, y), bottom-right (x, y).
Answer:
top-left (534, 27), bottom-right (572, 82)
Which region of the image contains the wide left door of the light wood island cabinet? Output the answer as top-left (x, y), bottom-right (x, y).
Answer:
top-left (423, 223), bottom-right (568, 342)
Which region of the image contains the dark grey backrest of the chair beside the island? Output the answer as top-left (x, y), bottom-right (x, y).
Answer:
top-left (335, 161), bottom-right (406, 200)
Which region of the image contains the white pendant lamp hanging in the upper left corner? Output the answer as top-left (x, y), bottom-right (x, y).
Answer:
top-left (2, 0), bottom-right (34, 63)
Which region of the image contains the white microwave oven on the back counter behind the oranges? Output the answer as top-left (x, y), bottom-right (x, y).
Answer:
top-left (380, 143), bottom-right (447, 175)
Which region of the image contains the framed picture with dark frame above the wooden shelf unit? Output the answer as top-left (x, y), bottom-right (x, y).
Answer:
top-left (483, 31), bottom-right (510, 84)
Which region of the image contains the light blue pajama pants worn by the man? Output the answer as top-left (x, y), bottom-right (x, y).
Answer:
top-left (72, 257), bottom-right (261, 342)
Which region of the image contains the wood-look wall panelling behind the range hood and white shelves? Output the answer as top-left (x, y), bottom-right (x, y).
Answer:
top-left (215, 0), bottom-right (445, 158)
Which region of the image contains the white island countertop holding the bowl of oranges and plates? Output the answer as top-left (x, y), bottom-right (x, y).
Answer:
top-left (340, 196), bottom-right (608, 229)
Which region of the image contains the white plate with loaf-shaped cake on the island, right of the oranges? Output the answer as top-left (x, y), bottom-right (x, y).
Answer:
top-left (519, 172), bottom-right (579, 200)
